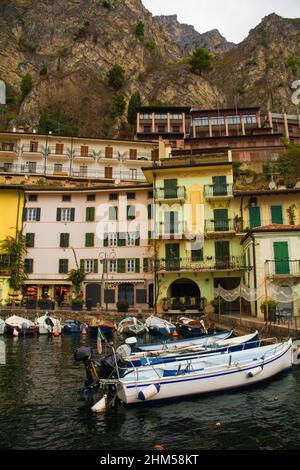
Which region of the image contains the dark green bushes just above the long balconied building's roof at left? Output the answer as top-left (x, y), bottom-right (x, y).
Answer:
top-left (38, 108), bottom-right (78, 136)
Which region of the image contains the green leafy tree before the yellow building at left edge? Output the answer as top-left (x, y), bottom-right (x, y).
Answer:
top-left (0, 231), bottom-right (27, 291)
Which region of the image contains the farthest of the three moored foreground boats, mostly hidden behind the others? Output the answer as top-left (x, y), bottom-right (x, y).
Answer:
top-left (136, 330), bottom-right (233, 351)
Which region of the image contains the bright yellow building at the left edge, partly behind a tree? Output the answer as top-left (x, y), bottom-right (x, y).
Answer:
top-left (0, 185), bottom-right (24, 304)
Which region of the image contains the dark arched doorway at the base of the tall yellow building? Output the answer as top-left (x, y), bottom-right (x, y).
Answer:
top-left (169, 279), bottom-right (201, 310)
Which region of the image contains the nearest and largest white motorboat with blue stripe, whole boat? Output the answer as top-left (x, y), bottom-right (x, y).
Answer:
top-left (89, 339), bottom-right (293, 405)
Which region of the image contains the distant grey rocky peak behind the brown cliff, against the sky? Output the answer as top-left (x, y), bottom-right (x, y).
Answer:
top-left (154, 15), bottom-right (234, 55)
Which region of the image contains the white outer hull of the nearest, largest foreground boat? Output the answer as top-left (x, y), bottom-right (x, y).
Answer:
top-left (117, 342), bottom-right (292, 405)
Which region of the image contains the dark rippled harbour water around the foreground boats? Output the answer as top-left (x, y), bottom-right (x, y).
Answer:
top-left (0, 336), bottom-right (300, 450)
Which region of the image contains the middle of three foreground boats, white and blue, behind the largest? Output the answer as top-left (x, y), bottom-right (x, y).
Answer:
top-left (116, 331), bottom-right (261, 367)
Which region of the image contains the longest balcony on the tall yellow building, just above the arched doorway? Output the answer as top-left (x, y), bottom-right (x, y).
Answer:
top-left (157, 256), bottom-right (246, 272)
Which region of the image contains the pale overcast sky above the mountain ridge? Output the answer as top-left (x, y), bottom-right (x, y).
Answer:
top-left (142, 0), bottom-right (300, 43)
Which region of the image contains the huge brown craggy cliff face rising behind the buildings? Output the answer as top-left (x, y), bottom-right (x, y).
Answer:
top-left (0, 0), bottom-right (300, 136)
